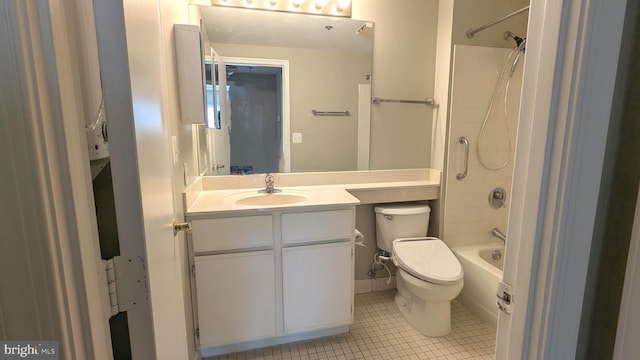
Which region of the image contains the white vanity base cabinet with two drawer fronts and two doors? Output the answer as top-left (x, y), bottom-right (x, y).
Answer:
top-left (189, 206), bottom-right (355, 357)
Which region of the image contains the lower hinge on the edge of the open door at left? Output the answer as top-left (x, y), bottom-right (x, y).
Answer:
top-left (102, 256), bottom-right (148, 316)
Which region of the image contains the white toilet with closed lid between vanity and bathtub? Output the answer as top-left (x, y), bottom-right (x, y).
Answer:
top-left (374, 203), bottom-right (463, 336)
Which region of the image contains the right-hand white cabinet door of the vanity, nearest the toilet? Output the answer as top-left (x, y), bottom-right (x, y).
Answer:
top-left (282, 242), bottom-right (353, 334)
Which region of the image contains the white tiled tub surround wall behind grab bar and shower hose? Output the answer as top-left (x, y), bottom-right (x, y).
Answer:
top-left (443, 45), bottom-right (522, 247)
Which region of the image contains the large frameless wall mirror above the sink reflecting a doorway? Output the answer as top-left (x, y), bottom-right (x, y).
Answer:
top-left (190, 5), bottom-right (373, 175)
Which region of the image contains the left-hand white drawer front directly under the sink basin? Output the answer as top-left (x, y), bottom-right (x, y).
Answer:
top-left (191, 215), bottom-right (273, 253)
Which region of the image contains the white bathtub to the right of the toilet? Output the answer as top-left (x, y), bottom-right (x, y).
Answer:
top-left (451, 244), bottom-right (504, 327)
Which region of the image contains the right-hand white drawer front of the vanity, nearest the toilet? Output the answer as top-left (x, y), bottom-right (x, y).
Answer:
top-left (282, 209), bottom-right (354, 244)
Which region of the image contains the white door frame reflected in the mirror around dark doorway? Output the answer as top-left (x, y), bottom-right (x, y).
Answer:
top-left (222, 56), bottom-right (291, 173)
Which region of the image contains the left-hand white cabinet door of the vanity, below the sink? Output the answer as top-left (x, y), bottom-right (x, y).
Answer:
top-left (195, 250), bottom-right (276, 347)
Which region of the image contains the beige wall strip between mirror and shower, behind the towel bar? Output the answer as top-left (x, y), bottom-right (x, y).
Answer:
top-left (352, 0), bottom-right (438, 170)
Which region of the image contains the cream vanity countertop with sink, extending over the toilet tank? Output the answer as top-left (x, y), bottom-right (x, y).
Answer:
top-left (184, 169), bottom-right (440, 217)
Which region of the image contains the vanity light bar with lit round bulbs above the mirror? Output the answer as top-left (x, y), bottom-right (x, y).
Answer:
top-left (209, 0), bottom-right (351, 18)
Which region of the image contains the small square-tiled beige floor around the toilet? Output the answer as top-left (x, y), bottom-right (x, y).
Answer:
top-left (208, 290), bottom-right (495, 360)
